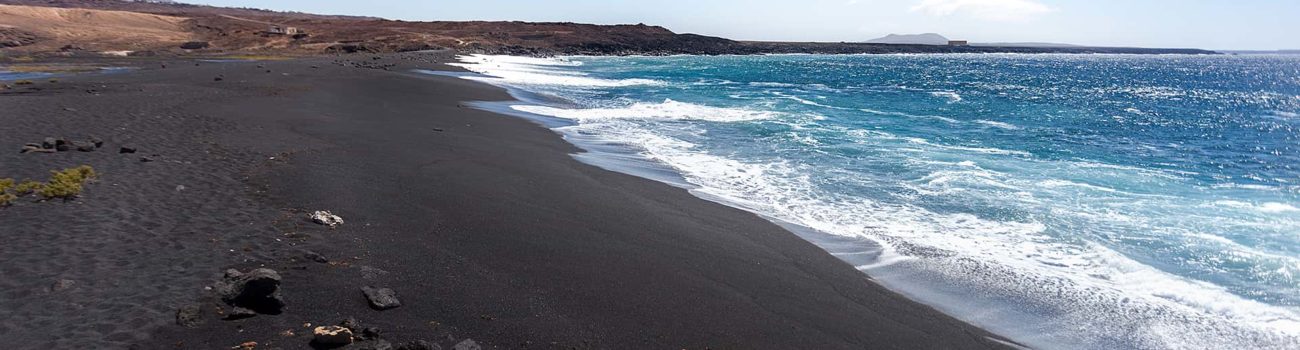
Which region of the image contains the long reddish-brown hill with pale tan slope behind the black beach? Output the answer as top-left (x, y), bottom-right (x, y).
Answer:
top-left (0, 0), bottom-right (736, 53)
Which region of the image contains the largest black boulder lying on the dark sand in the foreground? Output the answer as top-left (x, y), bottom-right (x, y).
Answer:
top-left (213, 268), bottom-right (285, 315)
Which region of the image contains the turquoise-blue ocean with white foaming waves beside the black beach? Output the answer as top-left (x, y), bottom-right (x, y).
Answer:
top-left (441, 55), bottom-right (1300, 349)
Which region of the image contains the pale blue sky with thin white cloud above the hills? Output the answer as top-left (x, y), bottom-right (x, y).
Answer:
top-left (183, 0), bottom-right (1300, 49)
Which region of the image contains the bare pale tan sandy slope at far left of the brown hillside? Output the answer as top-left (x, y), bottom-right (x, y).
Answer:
top-left (0, 5), bottom-right (192, 49)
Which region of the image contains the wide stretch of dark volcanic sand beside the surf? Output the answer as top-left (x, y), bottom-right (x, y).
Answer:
top-left (0, 53), bottom-right (1004, 349)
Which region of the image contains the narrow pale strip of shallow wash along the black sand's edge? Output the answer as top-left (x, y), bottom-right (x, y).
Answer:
top-left (434, 60), bottom-right (1045, 349)
